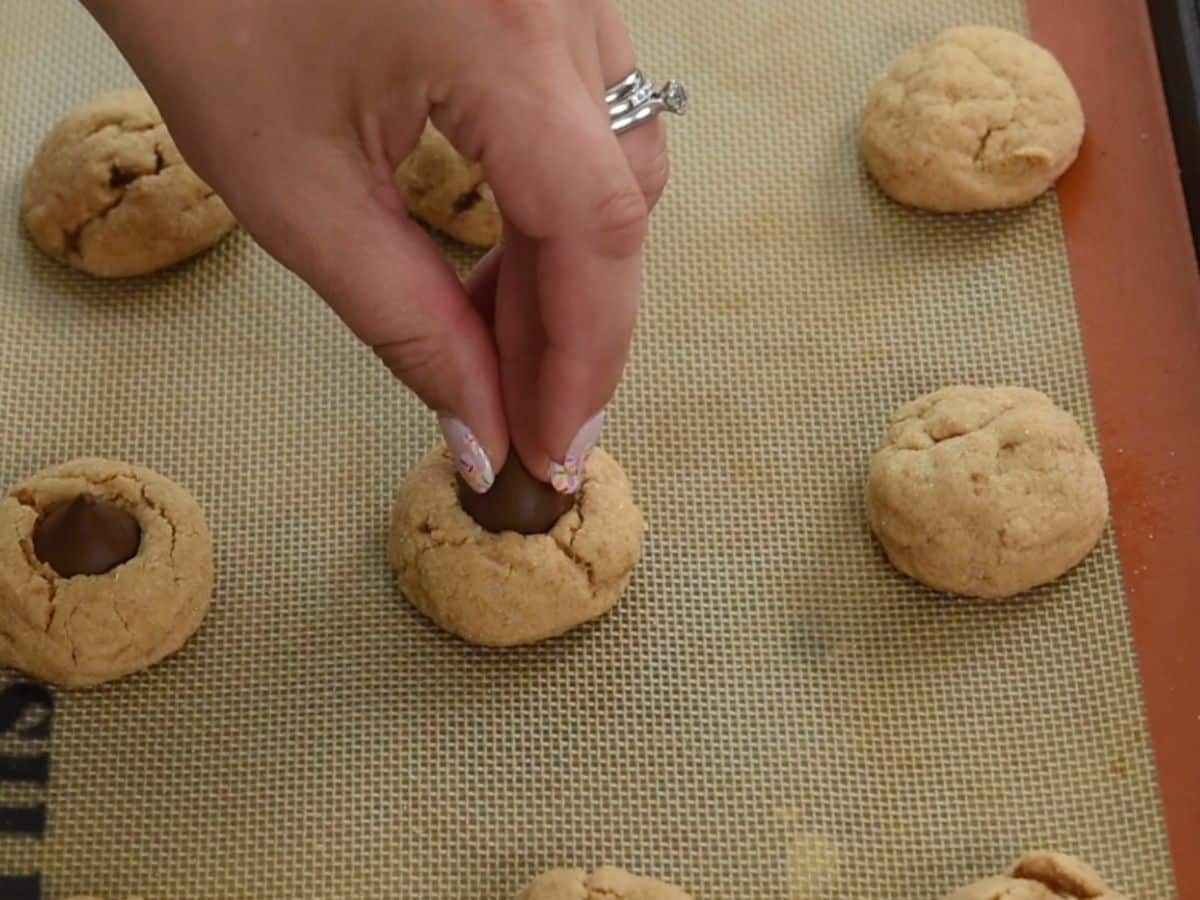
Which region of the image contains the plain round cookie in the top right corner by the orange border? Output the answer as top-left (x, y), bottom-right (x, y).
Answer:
top-left (859, 28), bottom-right (1084, 212)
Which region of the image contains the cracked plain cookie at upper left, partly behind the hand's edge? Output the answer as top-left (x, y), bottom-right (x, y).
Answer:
top-left (22, 90), bottom-right (234, 277)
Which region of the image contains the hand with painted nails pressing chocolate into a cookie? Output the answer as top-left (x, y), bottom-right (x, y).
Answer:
top-left (84, 0), bottom-right (667, 491)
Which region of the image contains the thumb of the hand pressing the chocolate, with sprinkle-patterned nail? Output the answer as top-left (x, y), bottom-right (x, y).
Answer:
top-left (256, 160), bottom-right (509, 492)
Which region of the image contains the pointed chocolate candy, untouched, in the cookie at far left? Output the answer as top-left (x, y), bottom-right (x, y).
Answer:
top-left (34, 493), bottom-right (142, 578)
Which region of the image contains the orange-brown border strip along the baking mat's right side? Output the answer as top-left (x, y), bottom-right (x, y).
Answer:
top-left (1027, 0), bottom-right (1200, 898)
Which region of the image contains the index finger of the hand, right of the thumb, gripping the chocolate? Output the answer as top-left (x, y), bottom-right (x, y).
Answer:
top-left (484, 70), bottom-right (648, 490)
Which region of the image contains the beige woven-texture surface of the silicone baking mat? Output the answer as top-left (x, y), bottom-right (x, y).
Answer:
top-left (0, 0), bottom-right (1174, 900)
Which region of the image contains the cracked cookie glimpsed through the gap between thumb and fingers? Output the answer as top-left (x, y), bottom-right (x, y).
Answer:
top-left (396, 122), bottom-right (500, 247)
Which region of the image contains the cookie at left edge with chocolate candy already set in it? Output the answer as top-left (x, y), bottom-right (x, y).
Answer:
top-left (0, 458), bottom-right (212, 688)
